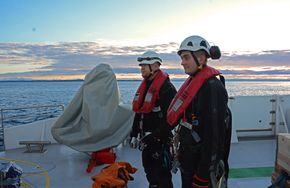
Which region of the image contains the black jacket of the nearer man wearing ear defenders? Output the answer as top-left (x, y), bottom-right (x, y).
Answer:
top-left (180, 77), bottom-right (228, 179)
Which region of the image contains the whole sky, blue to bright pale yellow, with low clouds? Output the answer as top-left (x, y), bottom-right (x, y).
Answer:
top-left (0, 0), bottom-right (290, 80)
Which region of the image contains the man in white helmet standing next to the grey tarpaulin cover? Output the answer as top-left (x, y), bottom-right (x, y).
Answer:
top-left (130, 51), bottom-right (176, 188)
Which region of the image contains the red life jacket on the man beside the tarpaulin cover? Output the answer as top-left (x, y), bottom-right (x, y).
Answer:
top-left (133, 70), bottom-right (168, 113)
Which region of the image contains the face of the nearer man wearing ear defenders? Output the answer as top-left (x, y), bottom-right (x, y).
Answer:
top-left (180, 51), bottom-right (198, 75)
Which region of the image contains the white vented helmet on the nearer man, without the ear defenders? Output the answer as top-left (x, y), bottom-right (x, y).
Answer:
top-left (177, 35), bottom-right (210, 57)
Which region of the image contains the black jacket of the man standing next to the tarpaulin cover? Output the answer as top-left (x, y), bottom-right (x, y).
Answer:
top-left (130, 76), bottom-right (176, 139)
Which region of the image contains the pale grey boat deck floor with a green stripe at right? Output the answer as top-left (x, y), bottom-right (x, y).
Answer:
top-left (0, 140), bottom-right (276, 188)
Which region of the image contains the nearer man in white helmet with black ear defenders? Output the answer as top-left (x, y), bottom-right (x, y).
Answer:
top-left (167, 36), bottom-right (231, 188)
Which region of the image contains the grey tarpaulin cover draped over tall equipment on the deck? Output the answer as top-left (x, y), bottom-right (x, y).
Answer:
top-left (51, 64), bottom-right (134, 152)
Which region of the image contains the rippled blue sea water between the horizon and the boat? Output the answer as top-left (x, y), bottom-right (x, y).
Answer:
top-left (0, 80), bottom-right (290, 126)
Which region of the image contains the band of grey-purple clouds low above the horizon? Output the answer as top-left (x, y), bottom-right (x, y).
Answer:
top-left (0, 42), bottom-right (290, 79)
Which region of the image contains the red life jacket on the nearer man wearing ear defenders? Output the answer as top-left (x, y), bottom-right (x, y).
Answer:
top-left (167, 66), bottom-right (220, 125)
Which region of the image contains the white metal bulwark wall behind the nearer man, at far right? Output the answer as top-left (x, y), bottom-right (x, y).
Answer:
top-left (229, 95), bottom-right (290, 142)
